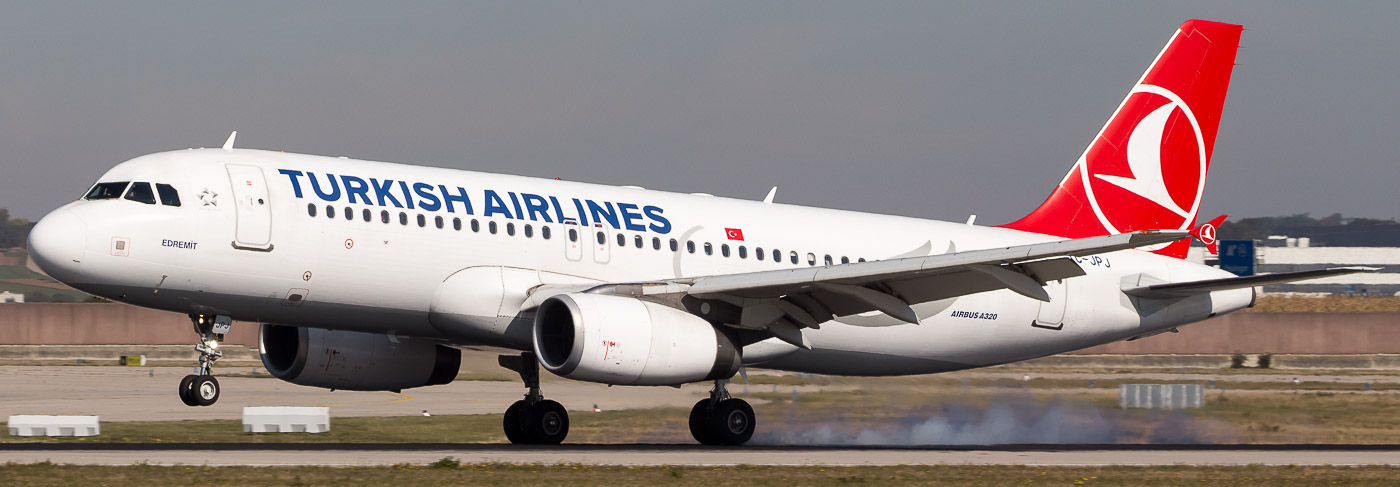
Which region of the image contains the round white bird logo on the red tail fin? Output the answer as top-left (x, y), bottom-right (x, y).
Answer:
top-left (1079, 84), bottom-right (1207, 234)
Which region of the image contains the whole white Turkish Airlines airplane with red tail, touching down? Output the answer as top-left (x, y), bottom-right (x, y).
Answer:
top-left (28, 20), bottom-right (1372, 445)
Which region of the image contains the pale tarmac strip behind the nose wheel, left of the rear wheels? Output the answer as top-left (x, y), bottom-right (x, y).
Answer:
top-left (0, 365), bottom-right (711, 423)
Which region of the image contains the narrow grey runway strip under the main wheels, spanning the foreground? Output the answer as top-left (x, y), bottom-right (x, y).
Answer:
top-left (0, 444), bottom-right (1400, 466)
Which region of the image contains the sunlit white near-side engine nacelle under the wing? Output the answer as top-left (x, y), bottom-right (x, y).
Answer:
top-left (533, 294), bottom-right (739, 385)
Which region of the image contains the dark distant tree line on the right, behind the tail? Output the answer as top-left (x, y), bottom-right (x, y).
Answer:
top-left (1219, 213), bottom-right (1400, 246)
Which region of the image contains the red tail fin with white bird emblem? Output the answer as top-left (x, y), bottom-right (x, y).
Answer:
top-left (1002, 20), bottom-right (1243, 257)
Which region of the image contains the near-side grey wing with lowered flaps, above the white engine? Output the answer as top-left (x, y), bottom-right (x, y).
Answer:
top-left (531, 231), bottom-right (1190, 348)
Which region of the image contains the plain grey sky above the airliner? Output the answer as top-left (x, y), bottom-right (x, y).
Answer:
top-left (0, 0), bottom-right (1400, 224)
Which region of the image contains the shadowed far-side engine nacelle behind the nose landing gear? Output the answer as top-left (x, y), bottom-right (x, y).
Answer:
top-left (258, 323), bottom-right (462, 392)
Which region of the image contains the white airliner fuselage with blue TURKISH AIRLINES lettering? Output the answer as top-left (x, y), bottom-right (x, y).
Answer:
top-left (31, 148), bottom-right (1253, 375)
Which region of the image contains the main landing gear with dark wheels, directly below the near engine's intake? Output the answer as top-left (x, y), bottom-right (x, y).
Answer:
top-left (497, 351), bottom-right (568, 445)
